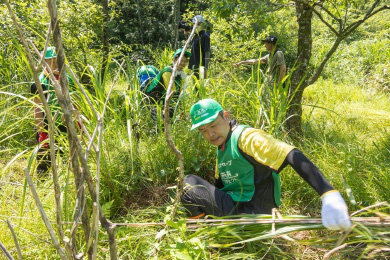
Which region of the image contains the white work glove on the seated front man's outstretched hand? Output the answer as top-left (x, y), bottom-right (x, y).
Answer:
top-left (321, 191), bottom-right (351, 231)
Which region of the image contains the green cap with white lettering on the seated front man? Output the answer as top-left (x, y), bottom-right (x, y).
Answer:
top-left (190, 99), bottom-right (223, 131)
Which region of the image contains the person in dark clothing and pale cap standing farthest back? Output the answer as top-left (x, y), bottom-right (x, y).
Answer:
top-left (188, 15), bottom-right (210, 79)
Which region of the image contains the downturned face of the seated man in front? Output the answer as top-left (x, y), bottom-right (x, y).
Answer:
top-left (198, 111), bottom-right (230, 146)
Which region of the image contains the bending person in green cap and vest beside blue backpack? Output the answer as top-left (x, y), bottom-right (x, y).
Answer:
top-left (145, 48), bottom-right (191, 119)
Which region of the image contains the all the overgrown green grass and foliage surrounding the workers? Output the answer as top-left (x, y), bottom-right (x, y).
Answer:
top-left (0, 1), bottom-right (390, 259)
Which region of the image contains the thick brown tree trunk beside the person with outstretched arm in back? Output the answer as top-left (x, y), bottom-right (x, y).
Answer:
top-left (287, 0), bottom-right (313, 136)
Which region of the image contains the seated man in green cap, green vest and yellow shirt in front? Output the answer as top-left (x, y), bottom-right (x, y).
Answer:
top-left (181, 99), bottom-right (351, 230)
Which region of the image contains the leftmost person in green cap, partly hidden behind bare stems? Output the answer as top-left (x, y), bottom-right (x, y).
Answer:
top-left (31, 47), bottom-right (73, 175)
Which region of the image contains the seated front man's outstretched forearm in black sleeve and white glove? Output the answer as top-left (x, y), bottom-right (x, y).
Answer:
top-left (279, 149), bottom-right (351, 230)
